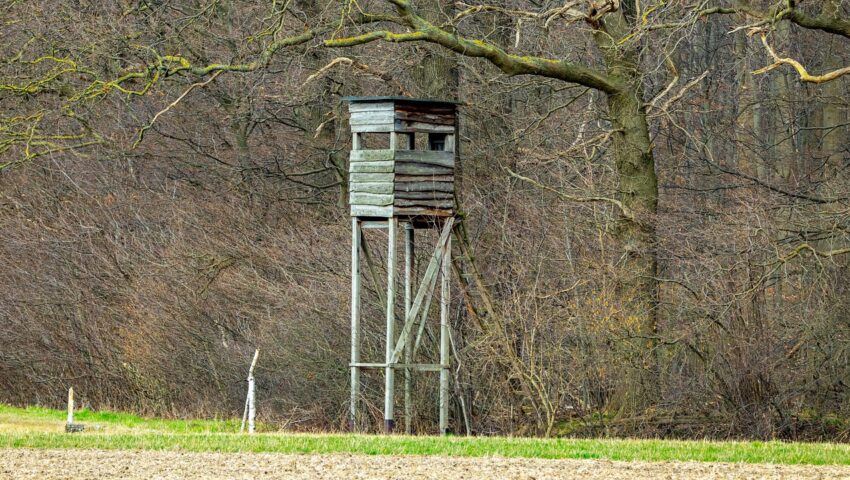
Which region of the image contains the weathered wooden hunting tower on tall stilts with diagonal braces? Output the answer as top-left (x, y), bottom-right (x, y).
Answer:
top-left (344, 97), bottom-right (457, 433)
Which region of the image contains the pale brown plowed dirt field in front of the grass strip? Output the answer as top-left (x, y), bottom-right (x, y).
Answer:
top-left (0, 449), bottom-right (850, 480)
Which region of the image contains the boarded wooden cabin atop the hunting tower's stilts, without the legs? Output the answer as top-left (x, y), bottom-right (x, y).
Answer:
top-left (345, 97), bottom-right (457, 221)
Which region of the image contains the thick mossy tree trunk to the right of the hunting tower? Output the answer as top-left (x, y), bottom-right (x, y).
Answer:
top-left (595, 7), bottom-right (659, 415)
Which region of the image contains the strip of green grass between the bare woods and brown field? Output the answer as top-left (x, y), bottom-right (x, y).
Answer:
top-left (0, 406), bottom-right (850, 465)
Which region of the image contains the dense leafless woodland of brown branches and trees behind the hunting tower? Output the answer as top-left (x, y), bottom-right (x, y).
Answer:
top-left (0, 0), bottom-right (850, 440)
